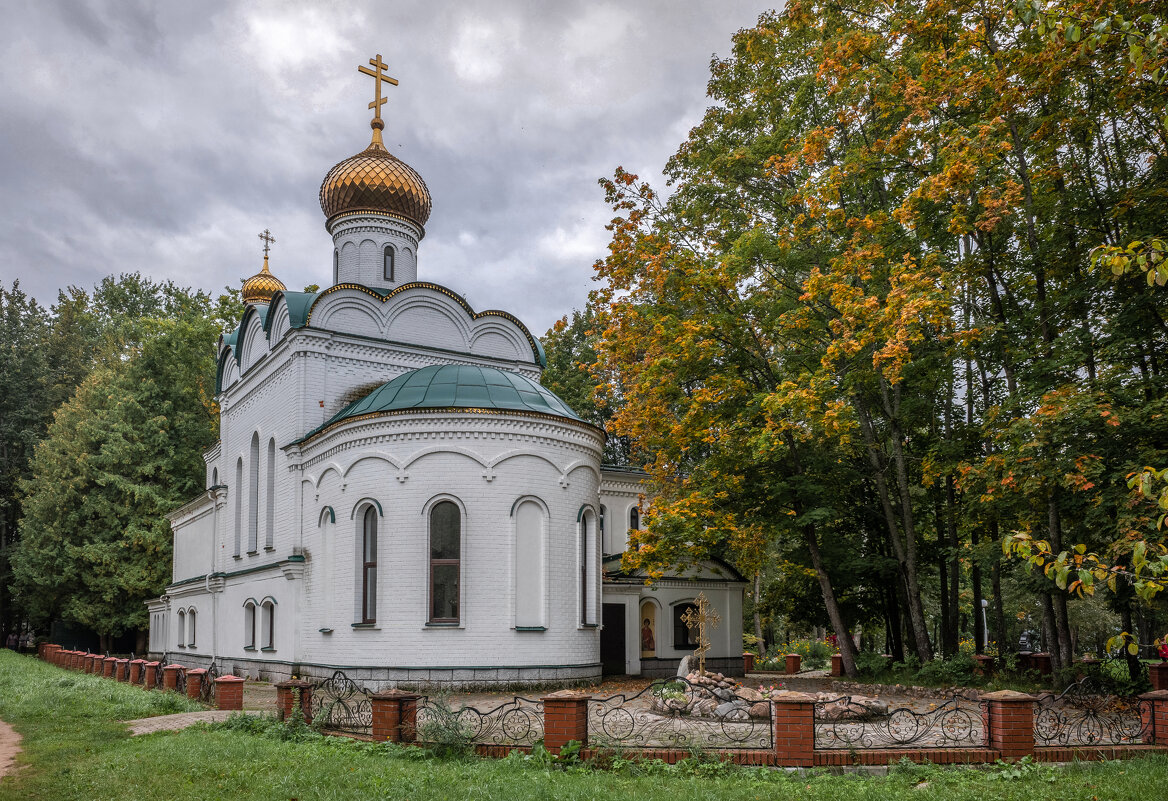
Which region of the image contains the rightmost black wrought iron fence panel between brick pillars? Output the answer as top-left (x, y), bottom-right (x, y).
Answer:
top-left (1034, 676), bottom-right (1150, 746)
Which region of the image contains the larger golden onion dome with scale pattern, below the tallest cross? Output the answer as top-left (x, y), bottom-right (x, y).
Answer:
top-left (320, 119), bottom-right (430, 227)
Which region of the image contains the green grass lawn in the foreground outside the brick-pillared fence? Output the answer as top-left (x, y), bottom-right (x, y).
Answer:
top-left (0, 652), bottom-right (1168, 801)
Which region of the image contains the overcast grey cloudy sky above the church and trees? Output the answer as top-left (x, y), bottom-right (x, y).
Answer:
top-left (0, 0), bottom-right (769, 335)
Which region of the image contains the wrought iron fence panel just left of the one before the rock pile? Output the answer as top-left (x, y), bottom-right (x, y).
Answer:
top-left (417, 696), bottom-right (543, 745)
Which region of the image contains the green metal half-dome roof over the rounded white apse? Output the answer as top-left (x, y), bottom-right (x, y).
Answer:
top-left (301, 364), bottom-right (584, 441)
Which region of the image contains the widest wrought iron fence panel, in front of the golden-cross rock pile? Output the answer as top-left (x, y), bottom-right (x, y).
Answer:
top-left (589, 677), bottom-right (774, 750)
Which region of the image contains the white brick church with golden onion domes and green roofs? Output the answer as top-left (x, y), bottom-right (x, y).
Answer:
top-left (148, 56), bottom-right (745, 687)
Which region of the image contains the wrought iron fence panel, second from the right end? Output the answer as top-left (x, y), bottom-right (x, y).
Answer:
top-left (813, 696), bottom-right (986, 750)
